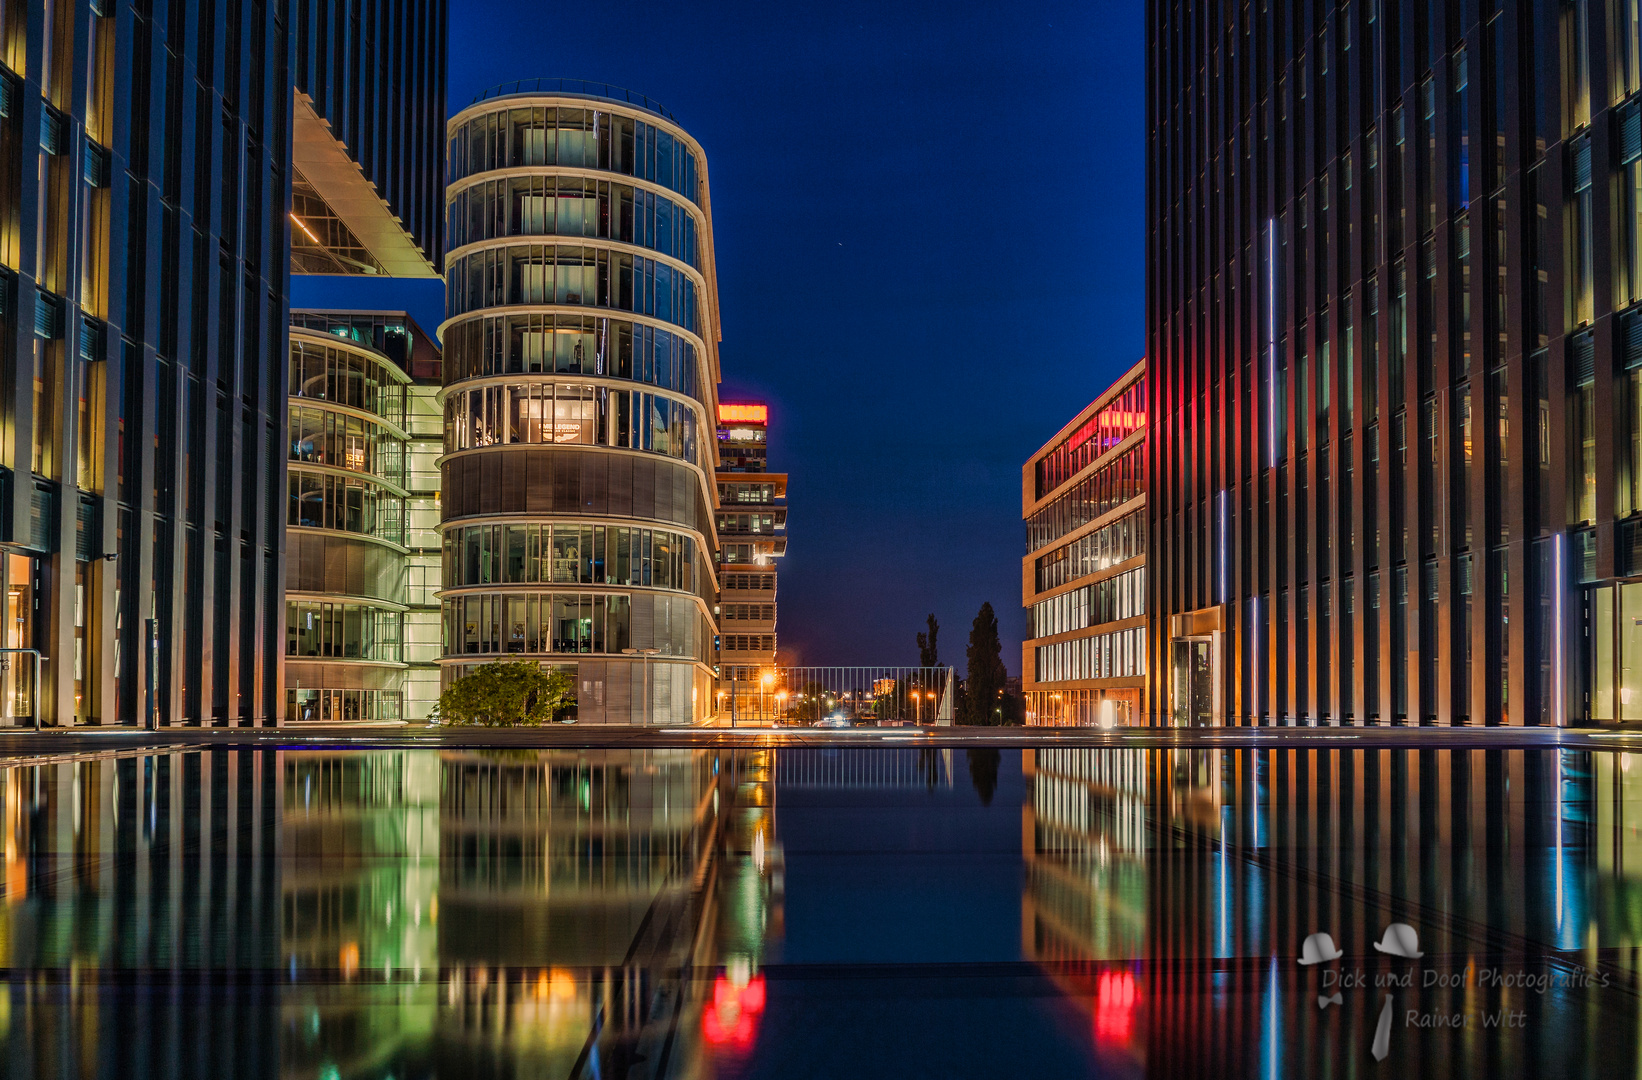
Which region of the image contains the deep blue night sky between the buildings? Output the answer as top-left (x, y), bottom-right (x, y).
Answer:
top-left (292, 0), bottom-right (1144, 675)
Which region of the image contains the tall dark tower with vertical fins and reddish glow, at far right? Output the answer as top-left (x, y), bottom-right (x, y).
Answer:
top-left (1146, 0), bottom-right (1642, 724)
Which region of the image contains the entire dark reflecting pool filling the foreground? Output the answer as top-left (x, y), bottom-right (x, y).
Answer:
top-left (0, 747), bottom-right (1642, 1080)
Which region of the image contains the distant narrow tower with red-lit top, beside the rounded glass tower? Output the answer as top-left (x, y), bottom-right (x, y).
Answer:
top-left (718, 402), bottom-right (787, 676)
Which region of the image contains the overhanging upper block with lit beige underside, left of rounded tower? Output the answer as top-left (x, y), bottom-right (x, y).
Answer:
top-left (286, 0), bottom-right (447, 277)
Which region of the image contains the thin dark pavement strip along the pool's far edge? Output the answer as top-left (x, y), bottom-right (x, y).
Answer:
top-left (0, 724), bottom-right (1642, 751)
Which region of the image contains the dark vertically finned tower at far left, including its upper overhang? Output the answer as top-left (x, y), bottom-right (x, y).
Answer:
top-left (0, 0), bottom-right (445, 725)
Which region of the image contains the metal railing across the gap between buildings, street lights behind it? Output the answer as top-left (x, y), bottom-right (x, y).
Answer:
top-left (718, 665), bottom-right (957, 727)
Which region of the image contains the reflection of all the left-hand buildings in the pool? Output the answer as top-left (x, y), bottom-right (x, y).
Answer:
top-left (0, 750), bottom-right (783, 1080)
